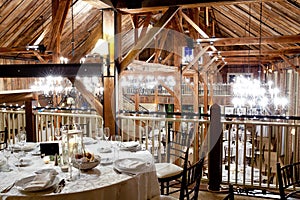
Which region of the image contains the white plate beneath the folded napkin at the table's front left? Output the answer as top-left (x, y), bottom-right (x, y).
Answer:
top-left (15, 176), bottom-right (59, 192)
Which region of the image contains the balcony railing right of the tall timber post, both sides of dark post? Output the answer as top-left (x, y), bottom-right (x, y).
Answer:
top-left (117, 114), bottom-right (300, 190)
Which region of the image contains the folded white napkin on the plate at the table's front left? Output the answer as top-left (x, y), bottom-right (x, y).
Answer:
top-left (24, 172), bottom-right (53, 191)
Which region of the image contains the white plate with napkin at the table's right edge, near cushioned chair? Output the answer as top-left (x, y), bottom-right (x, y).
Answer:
top-left (114, 158), bottom-right (149, 173)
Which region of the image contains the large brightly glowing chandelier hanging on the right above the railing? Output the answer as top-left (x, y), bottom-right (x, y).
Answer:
top-left (232, 76), bottom-right (288, 115)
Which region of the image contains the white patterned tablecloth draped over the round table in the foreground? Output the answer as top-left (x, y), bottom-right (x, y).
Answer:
top-left (0, 141), bottom-right (159, 200)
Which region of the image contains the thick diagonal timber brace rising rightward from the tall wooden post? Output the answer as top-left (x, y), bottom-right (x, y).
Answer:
top-left (119, 7), bottom-right (179, 73)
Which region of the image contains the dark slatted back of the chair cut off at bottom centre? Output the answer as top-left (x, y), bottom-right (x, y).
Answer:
top-left (179, 157), bottom-right (204, 200)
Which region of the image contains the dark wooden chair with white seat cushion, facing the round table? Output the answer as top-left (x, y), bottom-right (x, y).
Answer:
top-left (155, 130), bottom-right (192, 195)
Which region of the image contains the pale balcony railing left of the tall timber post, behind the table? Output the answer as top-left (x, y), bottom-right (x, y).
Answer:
top-left (0, 109), bottom-right (103, 142)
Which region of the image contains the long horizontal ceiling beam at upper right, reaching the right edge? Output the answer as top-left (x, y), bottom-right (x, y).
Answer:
top-left (197, 35), bottom-right (300, 46)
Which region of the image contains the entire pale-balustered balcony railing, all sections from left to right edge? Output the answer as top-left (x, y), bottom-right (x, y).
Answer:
top-left (0, 110), bottom-right (300, 193)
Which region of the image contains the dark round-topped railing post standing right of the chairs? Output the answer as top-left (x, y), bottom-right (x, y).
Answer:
top-left (208, 104), bottom-right (222, 191)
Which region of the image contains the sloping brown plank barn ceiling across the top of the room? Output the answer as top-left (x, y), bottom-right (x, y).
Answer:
top-left (0, 0), bottom-right (300, 68)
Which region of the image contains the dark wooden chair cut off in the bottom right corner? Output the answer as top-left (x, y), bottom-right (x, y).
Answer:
top-left (277, 162), bottom-right (300, 199)
